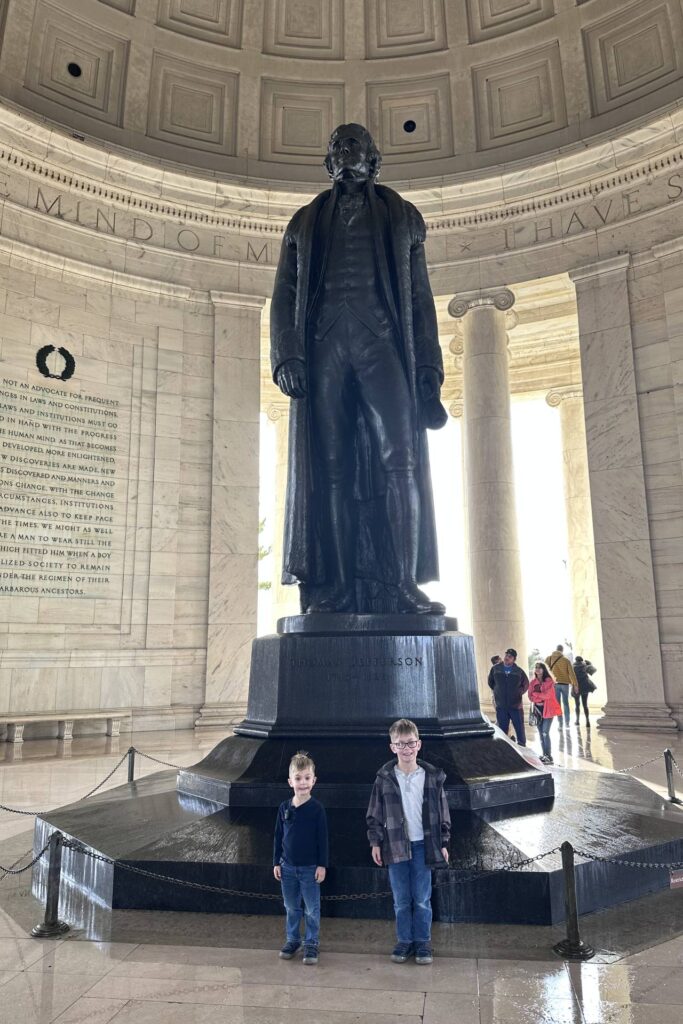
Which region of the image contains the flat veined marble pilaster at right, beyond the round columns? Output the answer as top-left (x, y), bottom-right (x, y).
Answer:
top-left (569, 260), bottom-right (676, 731)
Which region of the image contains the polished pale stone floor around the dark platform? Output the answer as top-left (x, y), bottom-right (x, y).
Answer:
top-left (0, 724), bottom-right (683, 1024)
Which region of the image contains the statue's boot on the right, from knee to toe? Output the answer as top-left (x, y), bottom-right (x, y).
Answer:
top-left (386, 470), bottom-right (445, 615)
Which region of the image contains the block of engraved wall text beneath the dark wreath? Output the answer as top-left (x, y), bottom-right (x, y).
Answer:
top-left (0, 377), bottom-right (125, 599)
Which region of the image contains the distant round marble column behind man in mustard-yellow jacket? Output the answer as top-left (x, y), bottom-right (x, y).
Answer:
top-left (546, 385), bottom-right (606, 705)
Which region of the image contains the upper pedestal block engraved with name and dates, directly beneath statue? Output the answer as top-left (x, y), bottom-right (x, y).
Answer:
top-left (234, 614), bottom-right (493, 740)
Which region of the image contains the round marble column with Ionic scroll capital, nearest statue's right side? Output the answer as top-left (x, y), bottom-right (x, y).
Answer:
top-left (449, 288), bottom-right (526, 699)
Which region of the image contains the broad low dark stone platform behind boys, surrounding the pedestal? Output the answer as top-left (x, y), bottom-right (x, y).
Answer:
top-left (34, 769), bottom-right (683, 925)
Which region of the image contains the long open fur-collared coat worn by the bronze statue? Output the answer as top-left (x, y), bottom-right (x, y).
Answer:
top-left (270, 183), bottom-right (443, 588)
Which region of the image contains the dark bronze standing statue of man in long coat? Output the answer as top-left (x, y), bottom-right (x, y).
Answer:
top-left (270, 124), bottom-right (446, 614)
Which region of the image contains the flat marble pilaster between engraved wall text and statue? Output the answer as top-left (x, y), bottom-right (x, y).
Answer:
top-left (196, 292), bottom-right (264, 726)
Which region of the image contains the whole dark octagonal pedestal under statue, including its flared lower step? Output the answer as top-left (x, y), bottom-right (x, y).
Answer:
top-left (177, 613), bottom-right (554, 810)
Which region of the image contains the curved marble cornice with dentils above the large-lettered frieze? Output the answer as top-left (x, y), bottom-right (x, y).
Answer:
top-left (0, 104), bottom-right (683, 234)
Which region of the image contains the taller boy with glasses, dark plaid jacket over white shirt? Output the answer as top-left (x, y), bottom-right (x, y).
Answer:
top-left (367, 718), bottom-right (451, 964)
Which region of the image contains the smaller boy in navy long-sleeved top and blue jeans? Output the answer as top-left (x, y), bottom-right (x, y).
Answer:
top-left (272, 751), bottom-right (328, 964)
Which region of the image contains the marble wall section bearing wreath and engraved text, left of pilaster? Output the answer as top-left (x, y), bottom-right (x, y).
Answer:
top-left (0, 244), bottom-right (214, 728)
